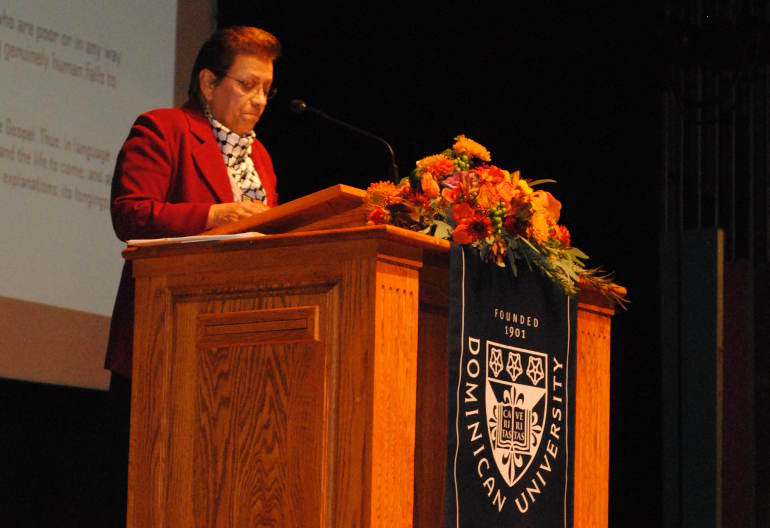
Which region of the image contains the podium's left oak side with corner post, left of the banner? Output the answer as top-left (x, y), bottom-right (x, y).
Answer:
top-left (128, 228), bottom-right (420, 527)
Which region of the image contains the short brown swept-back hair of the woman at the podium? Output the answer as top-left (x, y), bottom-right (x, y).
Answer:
top-left (187, 26), bottom-right (281, 103)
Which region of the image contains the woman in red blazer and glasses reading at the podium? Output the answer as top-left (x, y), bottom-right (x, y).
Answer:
top-left (105, 26), bottom-right (280, 522)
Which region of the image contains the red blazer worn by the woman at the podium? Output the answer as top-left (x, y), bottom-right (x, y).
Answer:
top-left (105, 102), bottom-right (278, 377)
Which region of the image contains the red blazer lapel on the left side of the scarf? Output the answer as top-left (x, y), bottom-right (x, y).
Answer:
top-left (182, 103), bottom-right (233, 203)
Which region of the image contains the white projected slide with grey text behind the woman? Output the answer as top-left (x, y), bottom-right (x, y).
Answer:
top-left (0, 0), bottom-right (176, 388)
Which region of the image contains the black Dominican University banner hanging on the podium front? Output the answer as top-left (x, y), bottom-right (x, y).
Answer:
top-left (444, 244), bottom-right (577, 528)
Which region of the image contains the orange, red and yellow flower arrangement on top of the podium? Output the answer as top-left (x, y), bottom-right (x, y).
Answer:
top-left (366, 135), bottom-right (627, 307)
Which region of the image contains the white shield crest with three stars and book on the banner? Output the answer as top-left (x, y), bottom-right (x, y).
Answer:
top-left (485, 341), bottom-right (548, 486)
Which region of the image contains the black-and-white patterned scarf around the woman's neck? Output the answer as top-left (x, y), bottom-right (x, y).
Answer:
top-left (206, 111), bottom-right (267, 204)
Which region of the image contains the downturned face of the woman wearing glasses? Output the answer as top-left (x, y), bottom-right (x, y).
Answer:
top-left (199, 55), bottom-right (273, 135)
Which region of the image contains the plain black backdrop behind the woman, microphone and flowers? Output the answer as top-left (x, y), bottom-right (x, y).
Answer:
top-left (0, 0), bottom-right (664, 527)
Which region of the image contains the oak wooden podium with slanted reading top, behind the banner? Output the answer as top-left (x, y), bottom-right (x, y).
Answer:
top-left (124, 186), bottom-right (612, 528)
